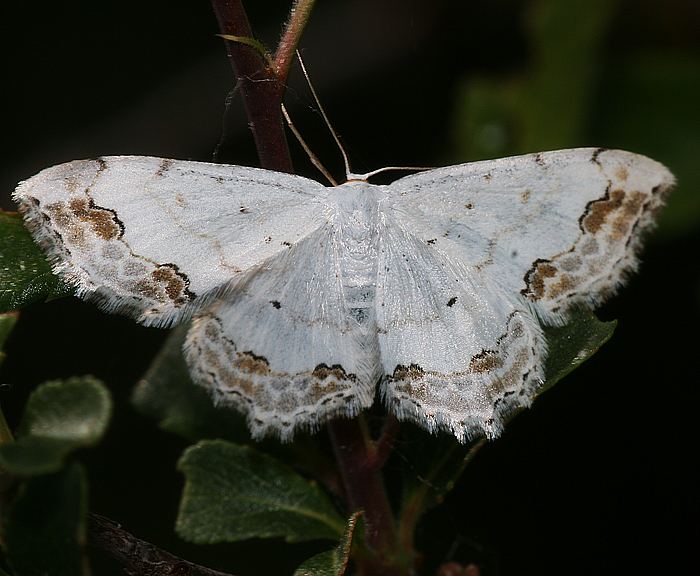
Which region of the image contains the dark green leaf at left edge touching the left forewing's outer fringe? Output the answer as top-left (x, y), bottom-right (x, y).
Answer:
top-left (0, 212), bottom-right (72, 312)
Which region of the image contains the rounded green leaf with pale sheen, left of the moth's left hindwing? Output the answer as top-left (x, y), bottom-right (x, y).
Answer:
top-left (0, 376), bottom-right (112, 476)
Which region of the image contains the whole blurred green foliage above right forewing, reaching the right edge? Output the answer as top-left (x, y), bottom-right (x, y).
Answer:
top-left (452, 0), bottom-right (700, 237)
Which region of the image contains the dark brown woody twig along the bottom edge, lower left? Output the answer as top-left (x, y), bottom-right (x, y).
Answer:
top-left (88, 514), bottom-right (232, 576)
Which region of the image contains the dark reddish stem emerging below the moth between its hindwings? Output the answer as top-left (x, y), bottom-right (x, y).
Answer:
top-left (328, 416), bottom-right (408, 576)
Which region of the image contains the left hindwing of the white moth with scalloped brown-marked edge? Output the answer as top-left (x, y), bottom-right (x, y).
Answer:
top-left (185, 220), bottom-right (380, 440)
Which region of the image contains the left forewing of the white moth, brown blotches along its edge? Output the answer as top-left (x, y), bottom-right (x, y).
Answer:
top-left (14, 156), bottom-right (326, 325)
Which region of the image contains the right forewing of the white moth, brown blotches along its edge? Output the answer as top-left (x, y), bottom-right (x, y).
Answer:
top-left (386, 148), bottom-right (674, 323)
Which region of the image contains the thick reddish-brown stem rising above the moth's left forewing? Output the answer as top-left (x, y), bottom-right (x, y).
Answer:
top-left (211, 0), bottom-right (292, 172)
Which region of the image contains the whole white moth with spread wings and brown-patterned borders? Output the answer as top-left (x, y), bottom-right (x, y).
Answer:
top-left (14, 149), bottom-right (673, 442)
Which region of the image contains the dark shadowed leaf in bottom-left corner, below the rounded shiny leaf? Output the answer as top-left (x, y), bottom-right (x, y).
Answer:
top-left (3, 463), bottom-right (87, 576)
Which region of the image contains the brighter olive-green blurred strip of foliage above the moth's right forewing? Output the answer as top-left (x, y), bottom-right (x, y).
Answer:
top-left (455, 0), bottom-right (618, 160)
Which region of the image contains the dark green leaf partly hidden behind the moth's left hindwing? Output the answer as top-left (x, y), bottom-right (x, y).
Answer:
top-left (131, 326), bottom-right (250, 442)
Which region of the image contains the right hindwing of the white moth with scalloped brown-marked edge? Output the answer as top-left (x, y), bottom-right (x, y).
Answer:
top-left (377, 215), bottom-right (545, 442)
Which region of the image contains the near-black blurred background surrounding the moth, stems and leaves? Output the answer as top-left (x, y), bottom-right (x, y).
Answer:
top-left (0, 0), bottom-right (700, 576)
